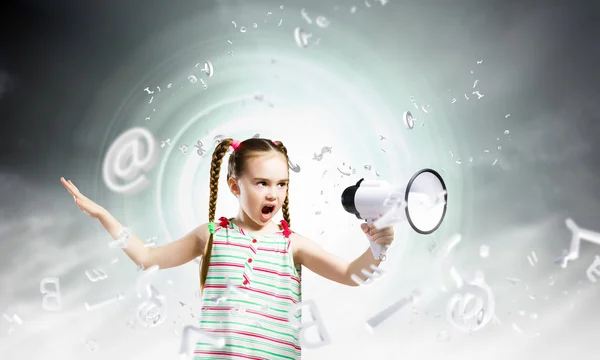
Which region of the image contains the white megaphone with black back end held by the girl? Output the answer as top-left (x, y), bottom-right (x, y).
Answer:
top-left (342, 169), bottom-right (448, 260)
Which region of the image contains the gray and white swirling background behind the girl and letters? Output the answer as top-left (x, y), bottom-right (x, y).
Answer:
top-left (0, 0), bottom-right (600, 359)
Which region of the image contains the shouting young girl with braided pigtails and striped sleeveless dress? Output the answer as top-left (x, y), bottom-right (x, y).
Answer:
top-left (61, 138), bottom-right (394, 359)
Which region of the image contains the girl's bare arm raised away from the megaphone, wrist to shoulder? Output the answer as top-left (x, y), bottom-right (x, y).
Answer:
top-left (98, 211), bottom-right (209, 269)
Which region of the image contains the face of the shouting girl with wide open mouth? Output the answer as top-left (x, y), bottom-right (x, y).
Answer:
top-left (228, 153), bottom-right (289, 226)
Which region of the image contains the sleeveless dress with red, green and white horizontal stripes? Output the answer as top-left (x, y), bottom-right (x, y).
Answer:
top-left (194, 218), bottom-right (302, 360)
